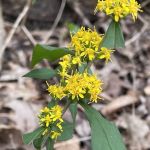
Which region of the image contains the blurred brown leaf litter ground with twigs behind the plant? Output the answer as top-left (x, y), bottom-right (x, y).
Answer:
top-left (0, 0), bottom-right (150, 150)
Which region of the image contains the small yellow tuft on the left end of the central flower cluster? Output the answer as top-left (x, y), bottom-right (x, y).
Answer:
top-left (47, 83), bottom-right (66, 100)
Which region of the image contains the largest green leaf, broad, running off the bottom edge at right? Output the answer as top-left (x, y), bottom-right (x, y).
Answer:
top-left (81, 103), bottom-right (126, 150)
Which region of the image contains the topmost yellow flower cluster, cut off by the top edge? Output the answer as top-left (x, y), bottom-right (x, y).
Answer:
top-left (95, 0), bottom-right (142, 22)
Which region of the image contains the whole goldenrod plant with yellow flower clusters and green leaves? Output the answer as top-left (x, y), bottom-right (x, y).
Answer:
top-left (23, 0), bottom-right (142, 150)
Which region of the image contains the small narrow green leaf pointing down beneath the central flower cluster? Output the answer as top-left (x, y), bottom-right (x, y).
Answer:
top-left (69, 102), bottom-right (77, 126)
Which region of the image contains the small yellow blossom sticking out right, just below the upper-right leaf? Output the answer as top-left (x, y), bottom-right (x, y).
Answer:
top-left (99, 47), bottom-right (114, 63)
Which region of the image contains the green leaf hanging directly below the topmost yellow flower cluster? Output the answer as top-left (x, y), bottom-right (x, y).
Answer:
top-left (100, 20), bottom-right (125, 49)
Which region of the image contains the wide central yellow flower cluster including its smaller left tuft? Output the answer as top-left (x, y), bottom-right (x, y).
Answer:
top-left (48, 73), bottom-right (102, 102)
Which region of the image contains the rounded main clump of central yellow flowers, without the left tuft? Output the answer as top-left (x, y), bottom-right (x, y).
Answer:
top-left (66, 73), bottom-right (102, 102)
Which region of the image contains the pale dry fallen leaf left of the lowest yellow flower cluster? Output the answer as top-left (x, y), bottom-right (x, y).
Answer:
top-left (5, 100), bottom-right (41, 132)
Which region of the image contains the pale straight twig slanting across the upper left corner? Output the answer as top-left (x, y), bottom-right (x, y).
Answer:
top-left (0, 1), bottom-right (30, 70)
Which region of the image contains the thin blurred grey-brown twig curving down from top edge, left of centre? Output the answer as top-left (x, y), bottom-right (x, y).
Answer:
top-left (42, 0), bottom-right (66, 44)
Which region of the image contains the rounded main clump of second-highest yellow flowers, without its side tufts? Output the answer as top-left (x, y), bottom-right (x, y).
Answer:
top-left (69, 27), bottom-right (103, 63)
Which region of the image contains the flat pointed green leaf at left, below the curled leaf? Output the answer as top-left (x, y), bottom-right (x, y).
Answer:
top-left (23, 68), bottom-right (57, 79)
